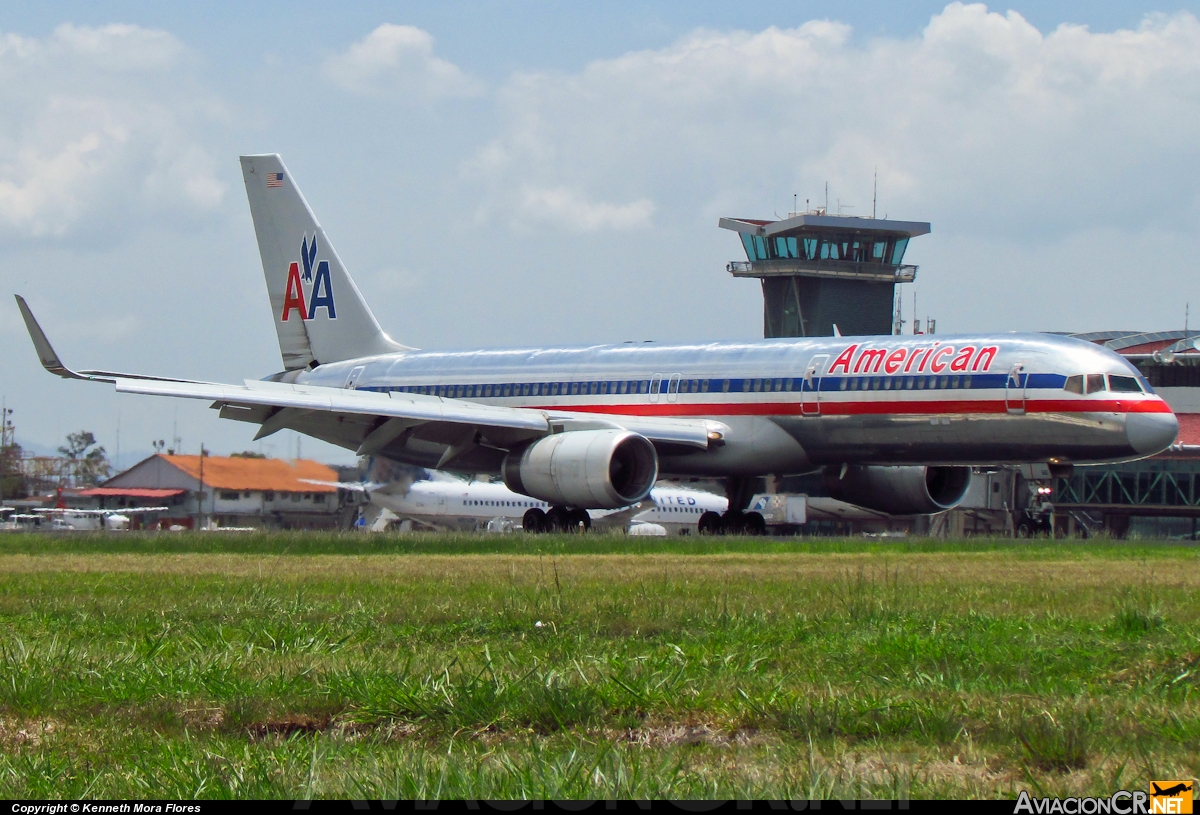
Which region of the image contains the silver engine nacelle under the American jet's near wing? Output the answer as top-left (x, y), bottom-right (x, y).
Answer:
top-left (503, 430), bottom-right (659, 509)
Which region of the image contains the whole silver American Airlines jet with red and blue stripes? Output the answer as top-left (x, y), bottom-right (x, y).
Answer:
top-left (17, 155), bottom-right (1178, 531)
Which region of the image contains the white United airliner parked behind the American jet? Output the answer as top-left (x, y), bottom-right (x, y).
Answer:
top-left (302, 474), bottom-right (728, 534)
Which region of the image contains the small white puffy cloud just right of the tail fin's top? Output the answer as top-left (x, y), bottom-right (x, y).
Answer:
top-left (324, 23), bottom-right (482, 100)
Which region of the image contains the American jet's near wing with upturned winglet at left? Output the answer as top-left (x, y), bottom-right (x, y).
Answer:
top-left (17, 295), bottom-right (728, 468)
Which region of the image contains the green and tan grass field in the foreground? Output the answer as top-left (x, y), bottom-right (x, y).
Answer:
top-left (0, 534), bottom-right (1200, 798)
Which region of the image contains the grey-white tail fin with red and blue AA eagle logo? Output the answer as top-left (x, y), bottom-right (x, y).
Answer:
top-left (241, 154), bottom-right (408, 371)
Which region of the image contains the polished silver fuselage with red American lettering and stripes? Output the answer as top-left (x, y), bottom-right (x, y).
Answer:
top-left (292, 334), bottom-right (1178, 475)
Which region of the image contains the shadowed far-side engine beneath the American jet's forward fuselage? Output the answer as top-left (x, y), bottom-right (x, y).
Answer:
top-left (826, 466), bottom-right (971, 515)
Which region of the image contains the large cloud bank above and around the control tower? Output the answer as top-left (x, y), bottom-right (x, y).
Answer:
top-left (463, 2), bottom-right (1200, 246)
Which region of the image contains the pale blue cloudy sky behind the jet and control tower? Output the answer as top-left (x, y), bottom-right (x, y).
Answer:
top-left (0, 1), bottom-right (1200, 466)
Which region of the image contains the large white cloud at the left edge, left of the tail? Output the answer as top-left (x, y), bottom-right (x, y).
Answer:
top-left (0, 24), bottom-right (224, 241)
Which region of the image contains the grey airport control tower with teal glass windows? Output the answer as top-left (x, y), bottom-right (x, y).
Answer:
top-left (719, 210), bottom-right (929, 338)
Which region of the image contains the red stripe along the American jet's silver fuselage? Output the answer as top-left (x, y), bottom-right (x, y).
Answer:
top-left (528, 398), bottom-right (1171, 417)
